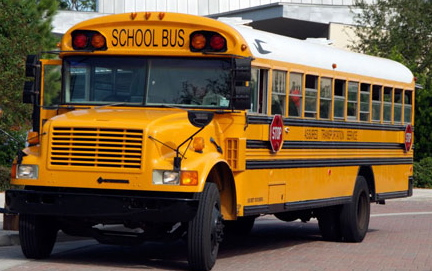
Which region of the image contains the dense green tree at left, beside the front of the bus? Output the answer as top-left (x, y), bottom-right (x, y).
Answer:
top-left (0, 0), bottom-right (58, 165)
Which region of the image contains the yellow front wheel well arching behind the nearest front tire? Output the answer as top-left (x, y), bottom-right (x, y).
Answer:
top-left (207, 162), bottom-right (237, 220)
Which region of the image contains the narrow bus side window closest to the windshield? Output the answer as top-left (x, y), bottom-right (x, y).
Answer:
top-left (250, 68), bottom-right (268, 114)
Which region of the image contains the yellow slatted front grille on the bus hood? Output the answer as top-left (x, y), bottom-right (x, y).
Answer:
top-left (49, 127), bottom-right (143, 169)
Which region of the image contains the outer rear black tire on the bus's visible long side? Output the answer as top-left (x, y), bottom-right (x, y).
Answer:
top-left (340, 176), bottom-right (370, 242)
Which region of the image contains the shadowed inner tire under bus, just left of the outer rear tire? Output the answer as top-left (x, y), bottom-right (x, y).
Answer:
top-left (317, 206), bottom-right (342, 242)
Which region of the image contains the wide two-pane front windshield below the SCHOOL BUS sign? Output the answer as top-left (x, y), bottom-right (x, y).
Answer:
top-left (63, 56), bottom-right (231, 108)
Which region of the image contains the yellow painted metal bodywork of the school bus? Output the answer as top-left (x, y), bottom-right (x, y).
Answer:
top-left (12, 12), bottom-right (414, 222)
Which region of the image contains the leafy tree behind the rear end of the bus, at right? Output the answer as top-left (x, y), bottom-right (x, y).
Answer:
top-left (351, 0), bottom-right (432, 160)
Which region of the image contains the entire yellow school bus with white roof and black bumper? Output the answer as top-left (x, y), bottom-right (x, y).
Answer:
top-left (6, 12), bottom-right (415, 270)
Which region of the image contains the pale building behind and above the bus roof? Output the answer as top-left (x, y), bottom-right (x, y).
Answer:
top-left (54, 0), bottom-right (372, 49)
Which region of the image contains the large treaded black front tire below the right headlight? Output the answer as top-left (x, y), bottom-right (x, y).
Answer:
top-left (188, 183), bottom-right (223, 270)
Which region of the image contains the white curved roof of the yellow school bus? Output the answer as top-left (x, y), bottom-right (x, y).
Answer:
top-left (230, 24), bottom-right (414, 84)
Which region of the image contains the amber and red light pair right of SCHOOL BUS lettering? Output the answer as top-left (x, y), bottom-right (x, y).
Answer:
top-left (190, 31), bottom-right (227, 52)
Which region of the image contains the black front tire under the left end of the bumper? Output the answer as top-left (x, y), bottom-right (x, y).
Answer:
top-left (19, 214), bottom-right (58, 259)
